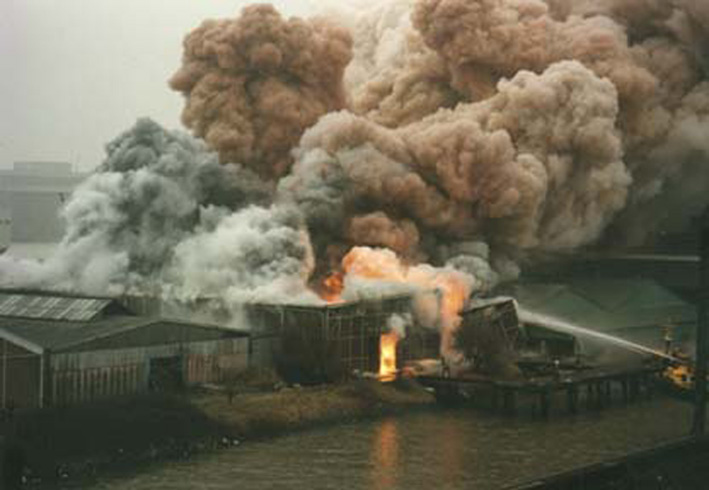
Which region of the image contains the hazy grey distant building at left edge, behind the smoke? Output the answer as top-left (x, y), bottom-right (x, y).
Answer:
top-left (0, 162), bottom-right (86, 243)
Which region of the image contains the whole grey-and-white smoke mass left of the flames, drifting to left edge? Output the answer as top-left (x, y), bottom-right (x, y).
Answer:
top-left (0, 119), bottom-right (312, 303)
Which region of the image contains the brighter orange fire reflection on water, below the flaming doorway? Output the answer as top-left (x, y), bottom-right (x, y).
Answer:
top-left (370, 419), bottom-right (400, 490)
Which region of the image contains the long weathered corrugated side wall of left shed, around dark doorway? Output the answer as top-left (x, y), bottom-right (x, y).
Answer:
top-left (51, 337), bottom-right (248, 405)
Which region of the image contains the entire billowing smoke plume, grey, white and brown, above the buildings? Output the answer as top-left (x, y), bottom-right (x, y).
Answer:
top-left (0, 0), bottom-right (709, 360)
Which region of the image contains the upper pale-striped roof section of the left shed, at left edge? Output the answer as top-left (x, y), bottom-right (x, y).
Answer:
top-left (0, 293), bottom-right (111, 322)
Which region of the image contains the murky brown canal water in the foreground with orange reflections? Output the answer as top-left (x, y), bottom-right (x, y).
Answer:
top-left (64, 398), bottom-right (691, 490)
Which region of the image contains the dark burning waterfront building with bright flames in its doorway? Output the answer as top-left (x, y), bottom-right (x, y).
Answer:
top-left (121, 292), bottom-right (440, 383)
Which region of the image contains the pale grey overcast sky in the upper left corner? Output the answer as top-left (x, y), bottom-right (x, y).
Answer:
top-left (0, 0), bottom-right (315, 169)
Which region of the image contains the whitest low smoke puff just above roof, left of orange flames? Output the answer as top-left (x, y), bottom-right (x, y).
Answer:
top-left (164, 206), bottom-right (321, 305)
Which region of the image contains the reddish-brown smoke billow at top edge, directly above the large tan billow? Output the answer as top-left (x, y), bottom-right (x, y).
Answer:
top-left (413, 0), bottom-right (657, 142)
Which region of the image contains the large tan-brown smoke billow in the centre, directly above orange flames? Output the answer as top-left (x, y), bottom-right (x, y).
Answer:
top-left (281, 62), bottom-right (631, 270)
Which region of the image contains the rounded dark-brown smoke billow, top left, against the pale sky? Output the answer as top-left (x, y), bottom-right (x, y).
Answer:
top-left (170, 5), bottom-right (351, 178)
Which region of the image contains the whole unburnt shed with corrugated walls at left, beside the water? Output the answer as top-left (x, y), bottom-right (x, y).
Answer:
top-left (0, 292), bottom-right (249, 408)
